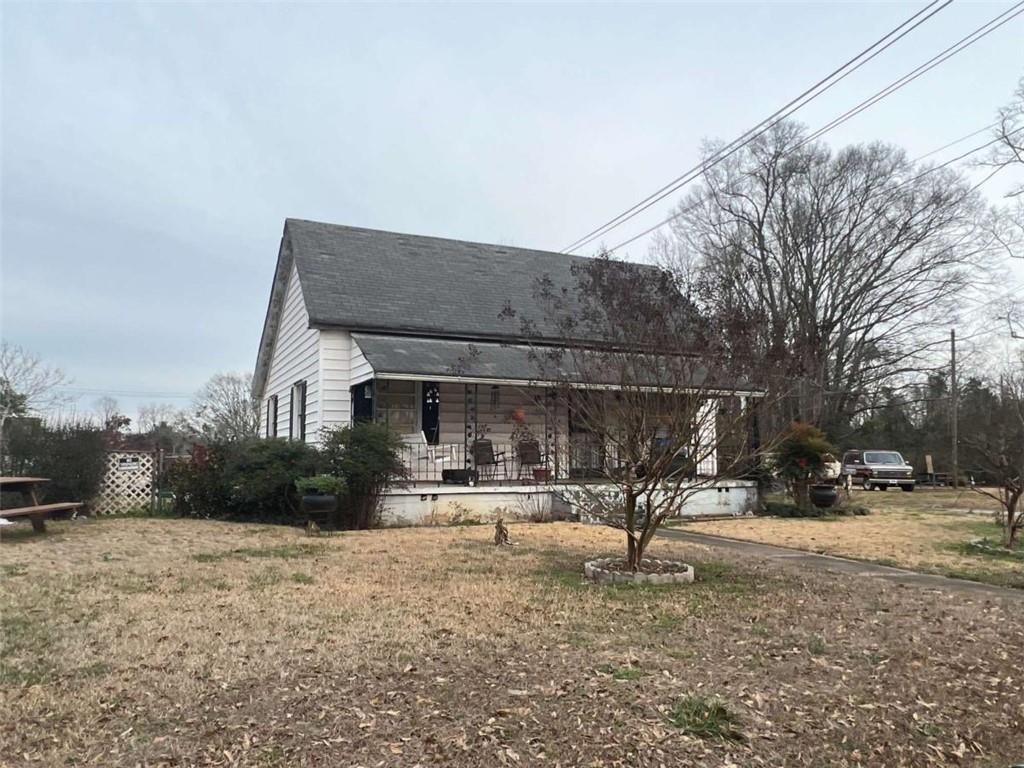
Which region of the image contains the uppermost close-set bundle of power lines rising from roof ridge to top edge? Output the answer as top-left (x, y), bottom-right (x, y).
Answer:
top-left (562, 0), bottom-right (952, 253)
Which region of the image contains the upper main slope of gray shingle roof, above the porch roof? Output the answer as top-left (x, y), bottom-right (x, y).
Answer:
top-left (285, 219), bottom-right (586, 338)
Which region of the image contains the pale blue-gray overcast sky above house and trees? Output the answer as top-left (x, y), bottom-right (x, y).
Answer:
top-left (0, 0), bottom-right (1024, 421)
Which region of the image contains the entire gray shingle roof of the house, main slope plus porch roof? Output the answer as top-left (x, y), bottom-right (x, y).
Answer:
top-left (253, 219), bottom-right (749, 394)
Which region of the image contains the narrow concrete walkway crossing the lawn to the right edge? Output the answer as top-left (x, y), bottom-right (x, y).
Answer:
top-left (657, 527), bottom-right (1024, 602)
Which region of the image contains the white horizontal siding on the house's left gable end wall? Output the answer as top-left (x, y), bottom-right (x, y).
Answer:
top-left (263, 266), bottom-right (321, 442)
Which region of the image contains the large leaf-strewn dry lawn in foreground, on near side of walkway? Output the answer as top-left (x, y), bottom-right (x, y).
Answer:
top-left (0, 519), bottom-right (1024, 768)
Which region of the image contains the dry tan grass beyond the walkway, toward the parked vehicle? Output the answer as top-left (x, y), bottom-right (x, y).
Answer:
top-left (671, 488), bottom-right (1024, 588)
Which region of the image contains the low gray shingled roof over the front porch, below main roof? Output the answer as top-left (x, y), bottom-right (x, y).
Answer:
top-left (352, 333), bottom-right (760, 395)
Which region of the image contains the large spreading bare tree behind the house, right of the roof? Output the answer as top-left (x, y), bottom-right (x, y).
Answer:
top-left (657, 123), bottom-right (996, 434)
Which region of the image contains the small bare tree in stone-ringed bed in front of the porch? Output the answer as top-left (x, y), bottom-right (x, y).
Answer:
top-left (516, 258), bottom-right (770, 570)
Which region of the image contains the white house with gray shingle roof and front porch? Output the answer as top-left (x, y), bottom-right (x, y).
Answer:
top-left (253, 219), bottom-right (753, 520)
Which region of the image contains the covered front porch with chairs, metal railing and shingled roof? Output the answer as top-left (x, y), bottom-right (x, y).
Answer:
top-left (350, 334), bottom-right (749, 487)
